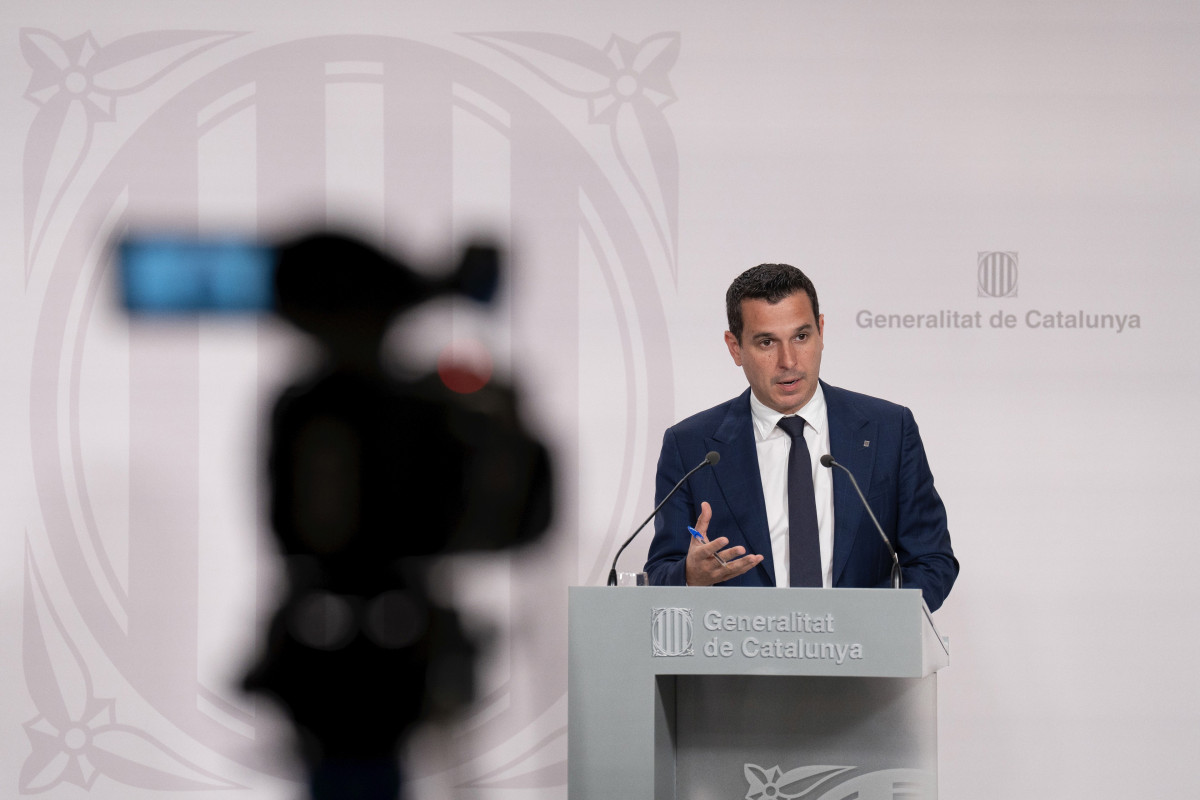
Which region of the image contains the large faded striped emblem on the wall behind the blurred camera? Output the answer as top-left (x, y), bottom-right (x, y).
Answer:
top-left (18, 30), bottom-right (679, 796)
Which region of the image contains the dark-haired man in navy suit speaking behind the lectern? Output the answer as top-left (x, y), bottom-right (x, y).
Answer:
top-left (646, 264), bottom-right (959, 610)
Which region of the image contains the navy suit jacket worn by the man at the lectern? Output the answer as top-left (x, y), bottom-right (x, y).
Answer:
top-left (646, 381), bottom-right (959, 610)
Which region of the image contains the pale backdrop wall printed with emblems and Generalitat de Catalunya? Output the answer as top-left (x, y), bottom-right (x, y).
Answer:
top-left (0, 0), bottom-right (1200, 800)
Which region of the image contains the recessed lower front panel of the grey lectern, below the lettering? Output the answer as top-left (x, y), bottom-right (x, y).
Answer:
top-left (676, 675), bottom-right (937, 800)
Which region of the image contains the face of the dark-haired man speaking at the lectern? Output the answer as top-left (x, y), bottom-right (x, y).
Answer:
top-left (725, 291), bottom-right (824, 414)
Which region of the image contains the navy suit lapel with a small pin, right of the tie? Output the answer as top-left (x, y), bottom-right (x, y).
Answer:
top-left (821, 381), bottom-right (877, 587)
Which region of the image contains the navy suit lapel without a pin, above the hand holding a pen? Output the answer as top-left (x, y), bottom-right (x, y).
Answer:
top-left (706, 389), bottom-right (775, 583)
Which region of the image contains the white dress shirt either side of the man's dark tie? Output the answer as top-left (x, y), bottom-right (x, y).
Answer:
top-left (750, 384), bottom-right (833, 588)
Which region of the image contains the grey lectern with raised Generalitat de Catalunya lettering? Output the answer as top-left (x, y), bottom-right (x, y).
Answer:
top-left (568, 587), bottom-right (949, 800)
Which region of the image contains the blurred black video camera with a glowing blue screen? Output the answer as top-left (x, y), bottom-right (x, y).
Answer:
top-left (118, 233), bottom-right (552, 798)
